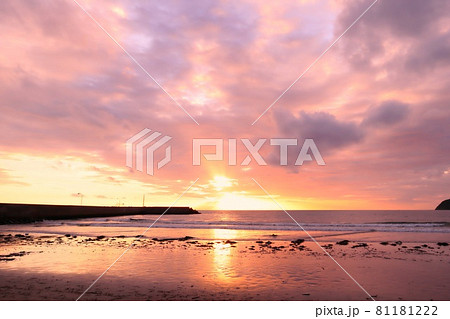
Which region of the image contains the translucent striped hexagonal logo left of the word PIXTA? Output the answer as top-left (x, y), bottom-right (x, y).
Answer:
top-left (125, 128), bottom-right (172, 175)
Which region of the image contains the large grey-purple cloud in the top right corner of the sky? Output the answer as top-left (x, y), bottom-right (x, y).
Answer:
top-left (335, 0), bottom-right (450, 77)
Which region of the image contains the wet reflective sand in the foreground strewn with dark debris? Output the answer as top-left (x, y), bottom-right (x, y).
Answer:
top-left (0, 233), bottom-right (450, 300)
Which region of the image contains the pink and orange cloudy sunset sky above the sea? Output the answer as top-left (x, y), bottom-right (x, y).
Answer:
top-left (0, 0), bottom-right (450, 209)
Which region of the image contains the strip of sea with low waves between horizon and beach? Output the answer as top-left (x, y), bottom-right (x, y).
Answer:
top-left (4, 210), bottom-right (450, 240)
